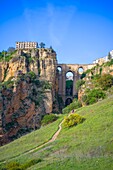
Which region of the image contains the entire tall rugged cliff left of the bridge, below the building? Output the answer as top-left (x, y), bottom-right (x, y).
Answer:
top-left (0, 49), bottom-right (57, 145)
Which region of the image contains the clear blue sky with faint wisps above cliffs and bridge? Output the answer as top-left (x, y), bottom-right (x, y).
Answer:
top-left (0, 0), bottom-right (113, 63)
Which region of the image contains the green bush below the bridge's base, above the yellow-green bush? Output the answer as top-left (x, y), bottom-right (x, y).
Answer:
top-left (62, 99), bottom-right (82, 114)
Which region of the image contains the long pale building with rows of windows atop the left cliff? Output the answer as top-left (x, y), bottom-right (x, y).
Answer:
top-left (16, 42), bottom-right (38, 50)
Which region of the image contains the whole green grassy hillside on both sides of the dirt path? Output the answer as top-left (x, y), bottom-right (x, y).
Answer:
top-left (0, 96), bottom-right (113, 170)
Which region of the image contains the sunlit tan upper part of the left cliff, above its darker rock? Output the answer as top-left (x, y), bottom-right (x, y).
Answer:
top-left (0, 48), bottom-right (57, 82)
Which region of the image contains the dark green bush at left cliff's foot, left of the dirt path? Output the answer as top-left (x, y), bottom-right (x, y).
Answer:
top-left (41, 114), bottom-right (58, 125)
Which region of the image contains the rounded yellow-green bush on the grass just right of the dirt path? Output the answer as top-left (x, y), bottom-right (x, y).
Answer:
top-left (63, 113), bottom-right (84, 128)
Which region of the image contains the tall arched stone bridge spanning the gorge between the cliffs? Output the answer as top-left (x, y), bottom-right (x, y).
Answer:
top-left (57, 64), bottom-right (95, 105)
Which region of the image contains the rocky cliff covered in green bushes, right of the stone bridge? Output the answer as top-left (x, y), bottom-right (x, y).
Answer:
top-left (76, 59), bottom-right (113, 105)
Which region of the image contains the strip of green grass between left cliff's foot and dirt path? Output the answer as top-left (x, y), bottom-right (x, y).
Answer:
top-left (0, 116), bottom-right (62, 162)
